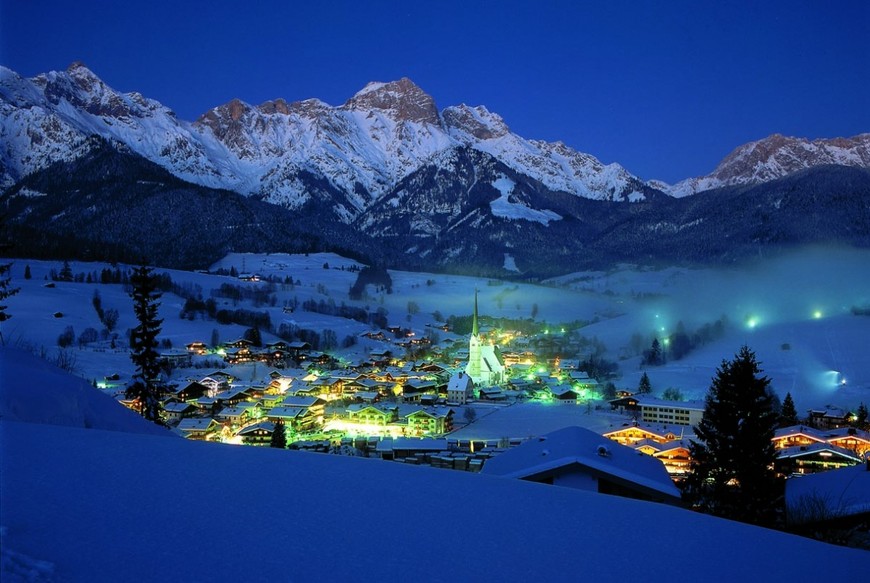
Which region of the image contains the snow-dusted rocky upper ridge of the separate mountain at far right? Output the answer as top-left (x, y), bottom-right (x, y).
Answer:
top-left (650, 134), bottom-right (870, 197)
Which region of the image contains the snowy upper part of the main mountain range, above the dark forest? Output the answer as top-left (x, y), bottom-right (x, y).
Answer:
top-left (0, 63), bottom-right (648, 214)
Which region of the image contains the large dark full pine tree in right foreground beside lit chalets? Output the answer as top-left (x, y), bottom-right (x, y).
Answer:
top-left (686, 346), bottom-right (781, 525)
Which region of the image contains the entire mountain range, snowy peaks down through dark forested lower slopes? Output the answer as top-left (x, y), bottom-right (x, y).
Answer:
top-left (0, 63), bottom-right (870, 275)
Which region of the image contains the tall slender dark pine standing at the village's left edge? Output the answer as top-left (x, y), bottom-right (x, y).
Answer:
top-left (127, 266), bottom-right (163, 423)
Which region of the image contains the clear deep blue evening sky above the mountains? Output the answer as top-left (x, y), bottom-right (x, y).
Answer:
top-left (0, 0), bottom-right (870, 181)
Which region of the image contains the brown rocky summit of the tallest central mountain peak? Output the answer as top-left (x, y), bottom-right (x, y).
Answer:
top-left (342, 77), bottom-right (440, 125)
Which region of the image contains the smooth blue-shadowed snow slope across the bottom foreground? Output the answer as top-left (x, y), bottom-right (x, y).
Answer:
top-left (0, 421), bottom-right (870, 581)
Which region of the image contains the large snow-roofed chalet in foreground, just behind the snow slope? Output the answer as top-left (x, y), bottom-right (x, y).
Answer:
top-left (481, 427), bottom-right (680, 505)
